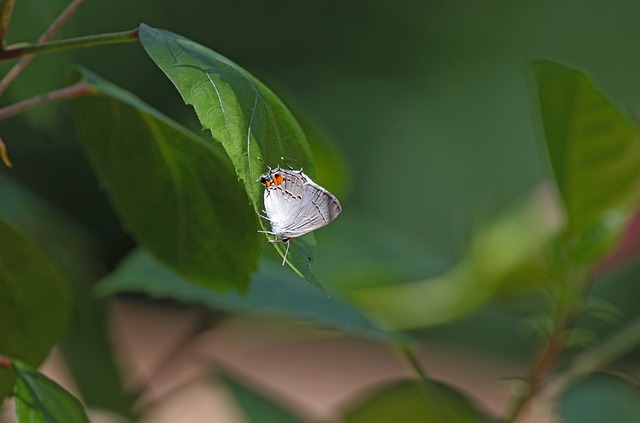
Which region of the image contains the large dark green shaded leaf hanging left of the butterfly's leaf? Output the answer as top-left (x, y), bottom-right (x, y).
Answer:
top-left (73, 71), bottom-right (261, 290)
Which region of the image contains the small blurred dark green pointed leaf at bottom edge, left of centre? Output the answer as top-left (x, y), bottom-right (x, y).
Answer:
top-left (220, 374), bottom-right (302, 423)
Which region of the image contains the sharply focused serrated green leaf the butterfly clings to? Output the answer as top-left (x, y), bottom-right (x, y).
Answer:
top-left (140, 24), bottom-right (320, 286)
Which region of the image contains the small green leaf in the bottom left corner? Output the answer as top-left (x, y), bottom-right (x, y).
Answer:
top-left (13, 360), bottom-right (89, 423)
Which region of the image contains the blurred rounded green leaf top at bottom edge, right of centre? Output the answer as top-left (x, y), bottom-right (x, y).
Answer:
top-left (344, 381), bottom-right (493, 423)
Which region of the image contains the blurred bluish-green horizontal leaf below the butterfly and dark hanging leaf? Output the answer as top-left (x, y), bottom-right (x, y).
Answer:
top-left (96, 249), bottom-right (401, 340)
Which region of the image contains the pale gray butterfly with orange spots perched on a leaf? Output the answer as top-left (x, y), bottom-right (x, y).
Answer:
top-left (258, 166), bottom-right (342, 265)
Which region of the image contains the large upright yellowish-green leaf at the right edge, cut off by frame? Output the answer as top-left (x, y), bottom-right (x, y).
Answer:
top-left (532, 61), bottom-right (640, 233)
